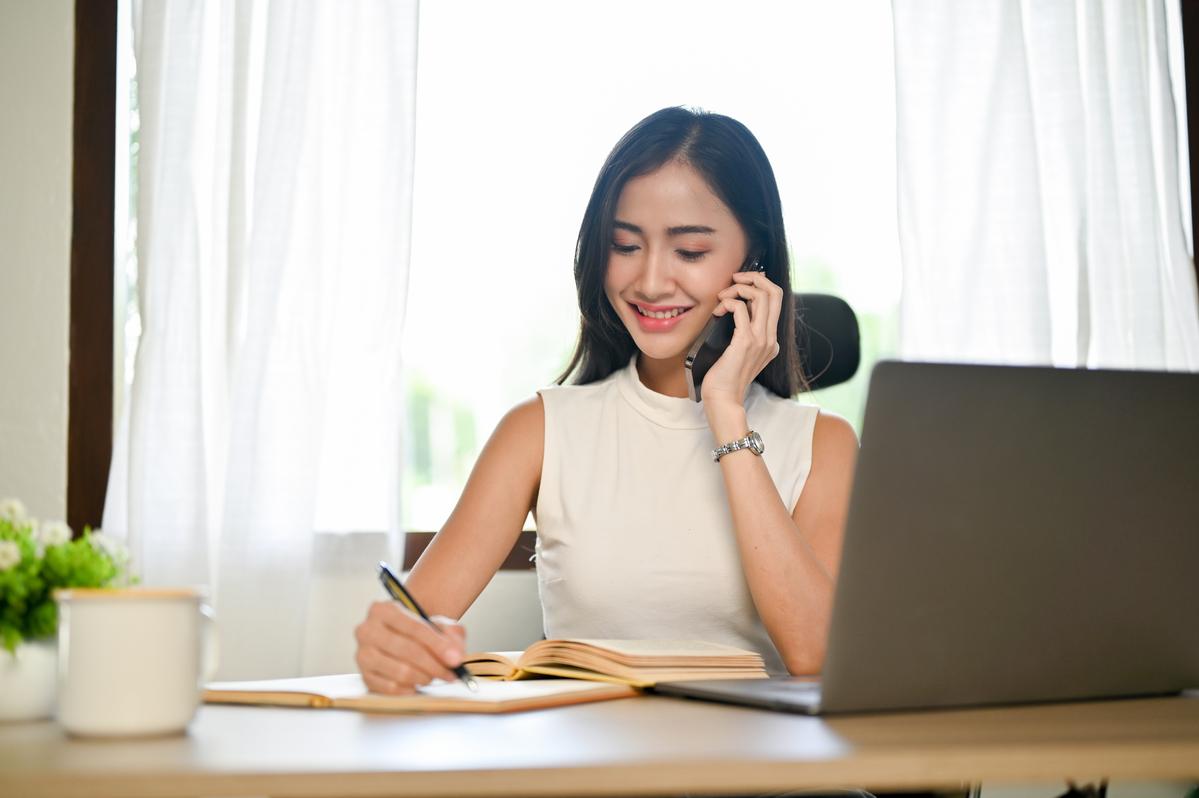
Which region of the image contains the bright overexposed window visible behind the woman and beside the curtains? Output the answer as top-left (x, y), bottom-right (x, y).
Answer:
top-left (114, 0), bottom-right (900, 530)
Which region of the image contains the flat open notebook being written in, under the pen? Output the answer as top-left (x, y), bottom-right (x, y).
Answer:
top-left (204, 673), bottom-right (639, 714)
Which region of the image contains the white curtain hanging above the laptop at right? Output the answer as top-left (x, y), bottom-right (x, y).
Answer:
top-left (893, 0), bottom-right (1199, 370)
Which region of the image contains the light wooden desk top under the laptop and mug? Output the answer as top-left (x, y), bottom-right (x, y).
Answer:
top-left (0, 696), bottom-right (1199, 798)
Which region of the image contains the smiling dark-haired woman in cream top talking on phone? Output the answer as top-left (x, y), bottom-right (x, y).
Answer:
top-left (357, 108), bottom-right (857, 693)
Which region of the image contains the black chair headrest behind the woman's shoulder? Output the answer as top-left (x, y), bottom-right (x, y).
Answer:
top-left (795, 294), bottom-right (862, 391)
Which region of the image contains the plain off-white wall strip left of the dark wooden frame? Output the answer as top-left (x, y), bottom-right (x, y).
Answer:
top-left (0, 0), bottom-right (74, 519)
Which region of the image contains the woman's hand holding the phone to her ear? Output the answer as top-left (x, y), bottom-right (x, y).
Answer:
top-left (700, 272), bottom-right (783, 416)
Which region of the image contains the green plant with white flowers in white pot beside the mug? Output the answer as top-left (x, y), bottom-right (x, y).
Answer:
top-left (0, 498), bottom-right (129, 720)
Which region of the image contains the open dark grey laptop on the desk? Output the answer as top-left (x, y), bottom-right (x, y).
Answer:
top-left (656, 362), bottom-right (1199, 714)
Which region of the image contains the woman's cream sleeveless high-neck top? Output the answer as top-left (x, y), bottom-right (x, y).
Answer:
top-left (535, 357), bottom-right (819, 673)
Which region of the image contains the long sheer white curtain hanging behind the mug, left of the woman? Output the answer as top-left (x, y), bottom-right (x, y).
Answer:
top-left (104, 0), bottom-right (417, 678)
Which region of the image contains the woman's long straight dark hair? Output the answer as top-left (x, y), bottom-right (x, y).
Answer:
top-left (558, 108), bottom-right (806, 397)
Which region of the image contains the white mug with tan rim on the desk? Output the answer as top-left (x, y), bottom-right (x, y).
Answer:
top-left (54, 588), bottom-right (216, 736)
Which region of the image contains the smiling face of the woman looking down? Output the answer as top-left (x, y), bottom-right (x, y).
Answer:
top-left (604, 161), bottom-right (746, 359)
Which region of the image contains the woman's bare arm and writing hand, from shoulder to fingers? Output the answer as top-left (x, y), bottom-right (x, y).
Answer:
top-left (355, 397), bottom-right (546, 693)
